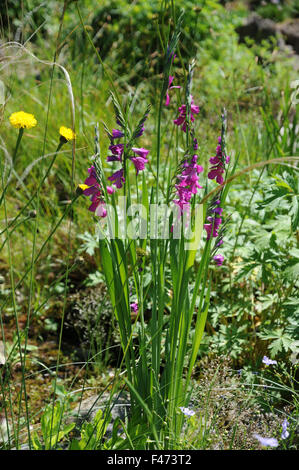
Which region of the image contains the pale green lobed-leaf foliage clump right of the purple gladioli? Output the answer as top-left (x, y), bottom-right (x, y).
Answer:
top-left (204, 169), bottom-right (299, 364)
